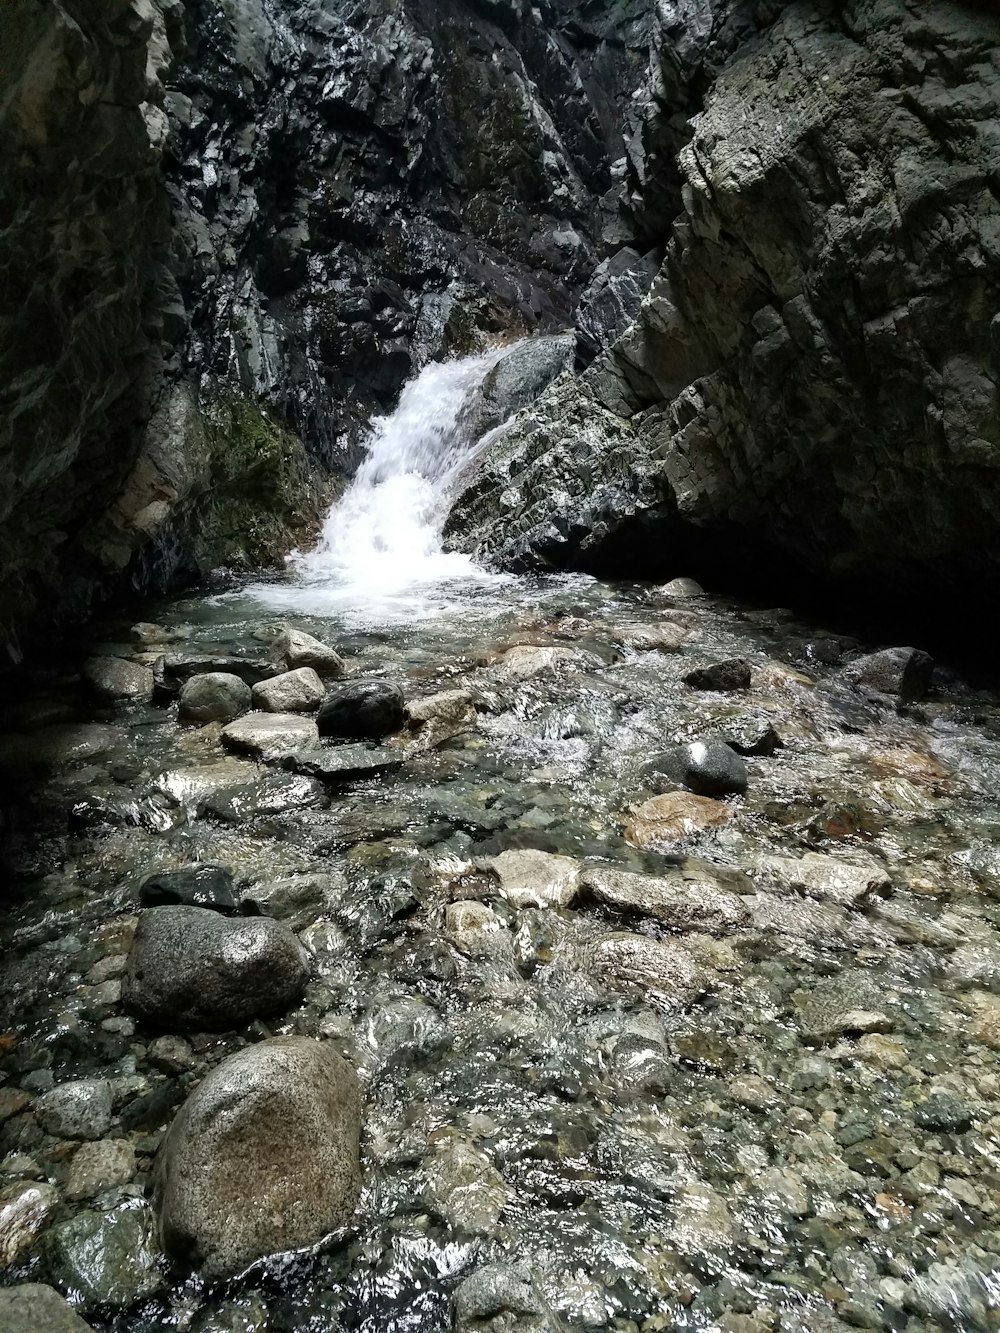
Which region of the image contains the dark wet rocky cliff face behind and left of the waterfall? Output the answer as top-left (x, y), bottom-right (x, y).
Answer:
top-left (0, 0), bottom-right (651, 655)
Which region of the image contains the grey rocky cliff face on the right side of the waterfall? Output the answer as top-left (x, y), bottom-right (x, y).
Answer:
top-left (452, 0), bottom-right (1000, 605)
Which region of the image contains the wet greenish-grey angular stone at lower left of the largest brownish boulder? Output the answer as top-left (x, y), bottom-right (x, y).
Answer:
top-left (44, 1200), bottom-right (163, 1309)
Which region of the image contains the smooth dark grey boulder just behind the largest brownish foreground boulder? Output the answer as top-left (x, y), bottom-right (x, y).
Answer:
top-left (122, 908), bottom-right (308, 1029)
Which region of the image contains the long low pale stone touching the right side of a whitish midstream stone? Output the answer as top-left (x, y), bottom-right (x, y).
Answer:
top-left (580, 862), bottom-right (752, 934)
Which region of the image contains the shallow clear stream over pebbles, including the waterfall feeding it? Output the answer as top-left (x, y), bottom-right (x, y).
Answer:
top-left (0, 356), bottom-right (1000, 1333)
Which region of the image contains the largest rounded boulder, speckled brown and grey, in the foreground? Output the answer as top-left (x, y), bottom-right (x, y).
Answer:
top-left (156, 1037), bottom-right (361, 1280)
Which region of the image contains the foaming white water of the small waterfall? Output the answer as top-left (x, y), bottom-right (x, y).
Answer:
top-left (248, 351), bottom-right (512, 624)
